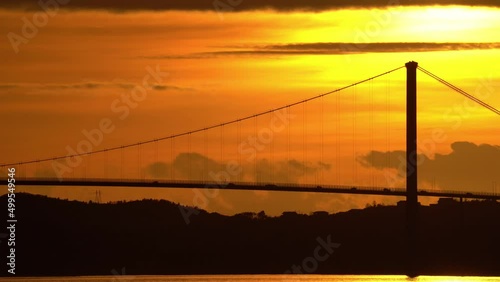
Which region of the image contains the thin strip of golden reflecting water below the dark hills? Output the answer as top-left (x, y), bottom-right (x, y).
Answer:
top-left (0, 275), bottom-right (500, 282)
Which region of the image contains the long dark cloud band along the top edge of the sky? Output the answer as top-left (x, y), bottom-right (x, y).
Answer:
top-left (0, 0), bottom-right (499, 12)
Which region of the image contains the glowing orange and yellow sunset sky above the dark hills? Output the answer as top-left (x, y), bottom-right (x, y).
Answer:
top-left (0, 0), bottom-right (500, 215)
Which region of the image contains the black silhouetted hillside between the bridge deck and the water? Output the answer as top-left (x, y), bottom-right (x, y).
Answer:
top-left (0, 193), bottom-right (500, 276)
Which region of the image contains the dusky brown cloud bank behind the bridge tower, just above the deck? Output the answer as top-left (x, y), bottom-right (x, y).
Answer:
top-left (358, 142), bottom-right (500, 192)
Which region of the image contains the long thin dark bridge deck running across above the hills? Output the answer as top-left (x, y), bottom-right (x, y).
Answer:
top-left (12, 178), bottom-right (500, 200)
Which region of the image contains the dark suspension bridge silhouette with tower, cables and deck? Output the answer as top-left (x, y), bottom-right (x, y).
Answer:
top-left (0, 62), bottom-right (500, 276)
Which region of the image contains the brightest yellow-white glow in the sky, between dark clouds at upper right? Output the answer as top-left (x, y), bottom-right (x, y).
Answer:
top-left (286, 6), bottom-right (500, 43)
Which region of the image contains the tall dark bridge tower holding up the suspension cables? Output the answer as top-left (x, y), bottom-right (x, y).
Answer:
top-left (405, 61), bottom-right (418, 277)
